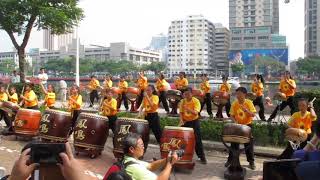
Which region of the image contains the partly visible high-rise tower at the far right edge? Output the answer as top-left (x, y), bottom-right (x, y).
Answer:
top-left (304, 0), bottom-right (320, 56)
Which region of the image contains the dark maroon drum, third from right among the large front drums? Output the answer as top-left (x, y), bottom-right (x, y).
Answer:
top-left (73, 113), bottom-right (109, 158)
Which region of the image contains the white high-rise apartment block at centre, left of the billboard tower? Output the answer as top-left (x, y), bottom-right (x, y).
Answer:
top-left (167, 15), bottom-right (215, 75)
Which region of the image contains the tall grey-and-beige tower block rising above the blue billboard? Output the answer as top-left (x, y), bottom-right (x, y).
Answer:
top-left (229, 0), bottom-right (286, 50)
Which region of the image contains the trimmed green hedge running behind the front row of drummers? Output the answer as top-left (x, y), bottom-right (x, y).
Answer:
top-left (118, 112), bottom-right (286, 147)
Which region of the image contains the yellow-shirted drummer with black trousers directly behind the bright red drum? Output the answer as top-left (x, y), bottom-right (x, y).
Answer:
top-left (179, 87), bottom-right (207, 164)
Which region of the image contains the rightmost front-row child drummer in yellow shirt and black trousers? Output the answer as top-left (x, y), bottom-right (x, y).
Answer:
top-left (278, 99), bottom-right (317, 159)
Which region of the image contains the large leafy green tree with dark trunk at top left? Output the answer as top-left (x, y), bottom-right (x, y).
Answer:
top-left (0, 0), bottom-right (84, 82)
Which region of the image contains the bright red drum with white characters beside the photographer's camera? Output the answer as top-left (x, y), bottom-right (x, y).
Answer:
top-left (160, 126), bottom-right (195, 169)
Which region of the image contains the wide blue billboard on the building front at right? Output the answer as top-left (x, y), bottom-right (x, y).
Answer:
top-left (228, 48), bottom-right (289, 65)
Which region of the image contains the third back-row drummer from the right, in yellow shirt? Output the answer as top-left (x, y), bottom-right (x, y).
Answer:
top-left (216, 76), bottom-right (231, 118)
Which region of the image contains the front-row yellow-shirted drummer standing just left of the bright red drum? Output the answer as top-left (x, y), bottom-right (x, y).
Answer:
top-left (139, 85), bottom-right (162, 144)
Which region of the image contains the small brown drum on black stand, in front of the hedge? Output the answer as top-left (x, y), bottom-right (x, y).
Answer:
top-left (222, 123), bottom-right (252, 144)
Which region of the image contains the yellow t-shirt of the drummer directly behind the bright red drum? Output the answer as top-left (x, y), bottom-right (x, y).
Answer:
top-left (179, 97), bottom-right (201, 121)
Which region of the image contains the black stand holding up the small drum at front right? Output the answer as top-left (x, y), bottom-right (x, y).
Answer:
top-left (222, 140), bottom-right (246, 180)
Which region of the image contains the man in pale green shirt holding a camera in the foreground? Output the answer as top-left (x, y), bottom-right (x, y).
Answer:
top-left (123, 133), bottom-right (178, 180)
